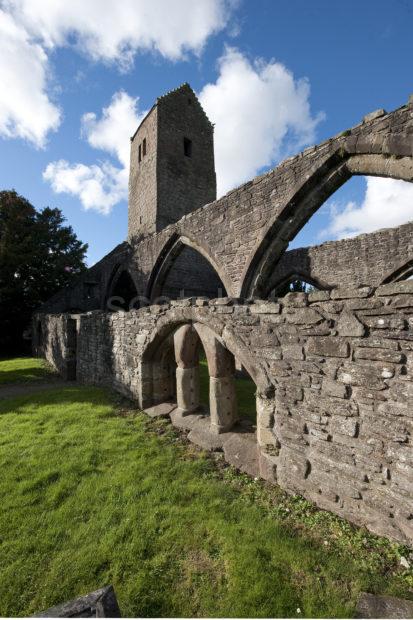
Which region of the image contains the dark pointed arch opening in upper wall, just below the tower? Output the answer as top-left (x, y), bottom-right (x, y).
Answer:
top-left (150, 243), bottom-right (227, 301)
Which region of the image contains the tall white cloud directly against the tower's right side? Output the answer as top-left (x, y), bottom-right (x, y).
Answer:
top-left (199, 48), bottom-right (324, 195)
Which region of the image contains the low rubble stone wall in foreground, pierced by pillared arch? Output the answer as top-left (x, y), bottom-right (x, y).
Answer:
top-left (37, 281), bottom-right (413, 544)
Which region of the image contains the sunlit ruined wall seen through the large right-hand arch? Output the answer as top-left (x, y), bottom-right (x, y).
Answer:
top-left (266, 220), bottom-right (413, 293)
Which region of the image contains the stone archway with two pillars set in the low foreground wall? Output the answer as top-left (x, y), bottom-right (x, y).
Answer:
top-left (139, 308), bottom-right (273, 434)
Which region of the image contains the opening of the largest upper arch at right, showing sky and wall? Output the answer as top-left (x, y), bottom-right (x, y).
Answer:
top-left (254, 174), bottom-right (413, 298)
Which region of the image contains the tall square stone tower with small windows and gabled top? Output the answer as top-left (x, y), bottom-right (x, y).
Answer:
top-left (128, 84), bottom-right (216, 241)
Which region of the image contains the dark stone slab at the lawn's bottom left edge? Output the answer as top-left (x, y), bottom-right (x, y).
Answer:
top-left (33, 586), bottom-right (121, 618)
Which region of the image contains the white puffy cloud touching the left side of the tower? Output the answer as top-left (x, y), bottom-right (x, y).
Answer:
top-left (43, 91), bottom-right (146, 214)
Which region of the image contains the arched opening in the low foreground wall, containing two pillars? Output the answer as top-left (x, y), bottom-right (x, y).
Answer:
top-left (142, 323), bottom-right (256, 434)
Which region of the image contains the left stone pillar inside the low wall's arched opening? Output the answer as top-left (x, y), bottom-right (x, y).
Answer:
top-left (174, 325), bottom-right (200, 415)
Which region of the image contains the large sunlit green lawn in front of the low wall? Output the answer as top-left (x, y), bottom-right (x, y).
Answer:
top-left (0, 380), bottom-right (413, 617)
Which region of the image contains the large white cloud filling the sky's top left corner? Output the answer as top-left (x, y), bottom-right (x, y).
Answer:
top-left (0, 0), bottom-right (235, 147)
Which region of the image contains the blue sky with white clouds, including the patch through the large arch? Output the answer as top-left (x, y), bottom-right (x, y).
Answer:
top-left (0, 0), bottom-right (413, 264)
